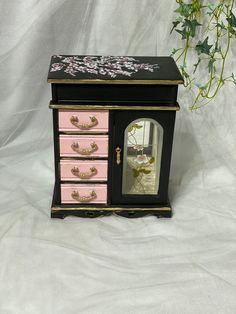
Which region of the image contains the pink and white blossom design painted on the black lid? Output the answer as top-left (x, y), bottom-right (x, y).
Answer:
top-left (50, 55), bottom-right (159, 78)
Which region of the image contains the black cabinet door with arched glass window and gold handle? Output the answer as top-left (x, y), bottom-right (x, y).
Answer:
top-left (112, 111), bottom-right (175, 205)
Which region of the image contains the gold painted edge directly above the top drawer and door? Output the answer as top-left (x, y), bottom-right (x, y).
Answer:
top-left (49, 103), bottom-right (180, 111)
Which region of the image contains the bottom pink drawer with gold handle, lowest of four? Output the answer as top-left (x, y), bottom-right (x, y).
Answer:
top-left (61, 184), bottom-right (107, 204)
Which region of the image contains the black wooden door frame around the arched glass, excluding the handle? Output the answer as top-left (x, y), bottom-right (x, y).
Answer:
top-left (112, 111), bottom-right (175, 205)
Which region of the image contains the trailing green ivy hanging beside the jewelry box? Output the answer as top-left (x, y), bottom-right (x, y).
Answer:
top-left (171, 0), bottom-right (236, 110)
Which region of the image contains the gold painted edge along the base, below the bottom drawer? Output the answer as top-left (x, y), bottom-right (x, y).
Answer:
top-left (51, 206), bottom-right (171, 212)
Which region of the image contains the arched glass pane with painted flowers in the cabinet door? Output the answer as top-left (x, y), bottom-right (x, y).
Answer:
top-left (122, 118), bottom-right (163, 195)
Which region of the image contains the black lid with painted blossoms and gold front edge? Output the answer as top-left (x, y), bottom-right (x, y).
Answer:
top-left (48, 55), bottom-right (183, 85)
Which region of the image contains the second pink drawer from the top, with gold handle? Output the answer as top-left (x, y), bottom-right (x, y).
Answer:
top-left (60, 135), bottom-right (108, 157)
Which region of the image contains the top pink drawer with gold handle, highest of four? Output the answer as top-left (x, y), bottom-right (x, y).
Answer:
top-left (59, 109), bottom-right (108, 132)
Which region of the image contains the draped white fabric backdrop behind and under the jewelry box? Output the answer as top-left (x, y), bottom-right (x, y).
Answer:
top-left (0, 0), bottom-right (236, 314)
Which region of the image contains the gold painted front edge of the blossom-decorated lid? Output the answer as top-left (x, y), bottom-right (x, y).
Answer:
top-left (47, 79), bottom-right (184, 85)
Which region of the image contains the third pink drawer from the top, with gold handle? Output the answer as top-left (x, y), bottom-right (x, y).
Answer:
top-left (60, 160), bottom-right (107, 181)
